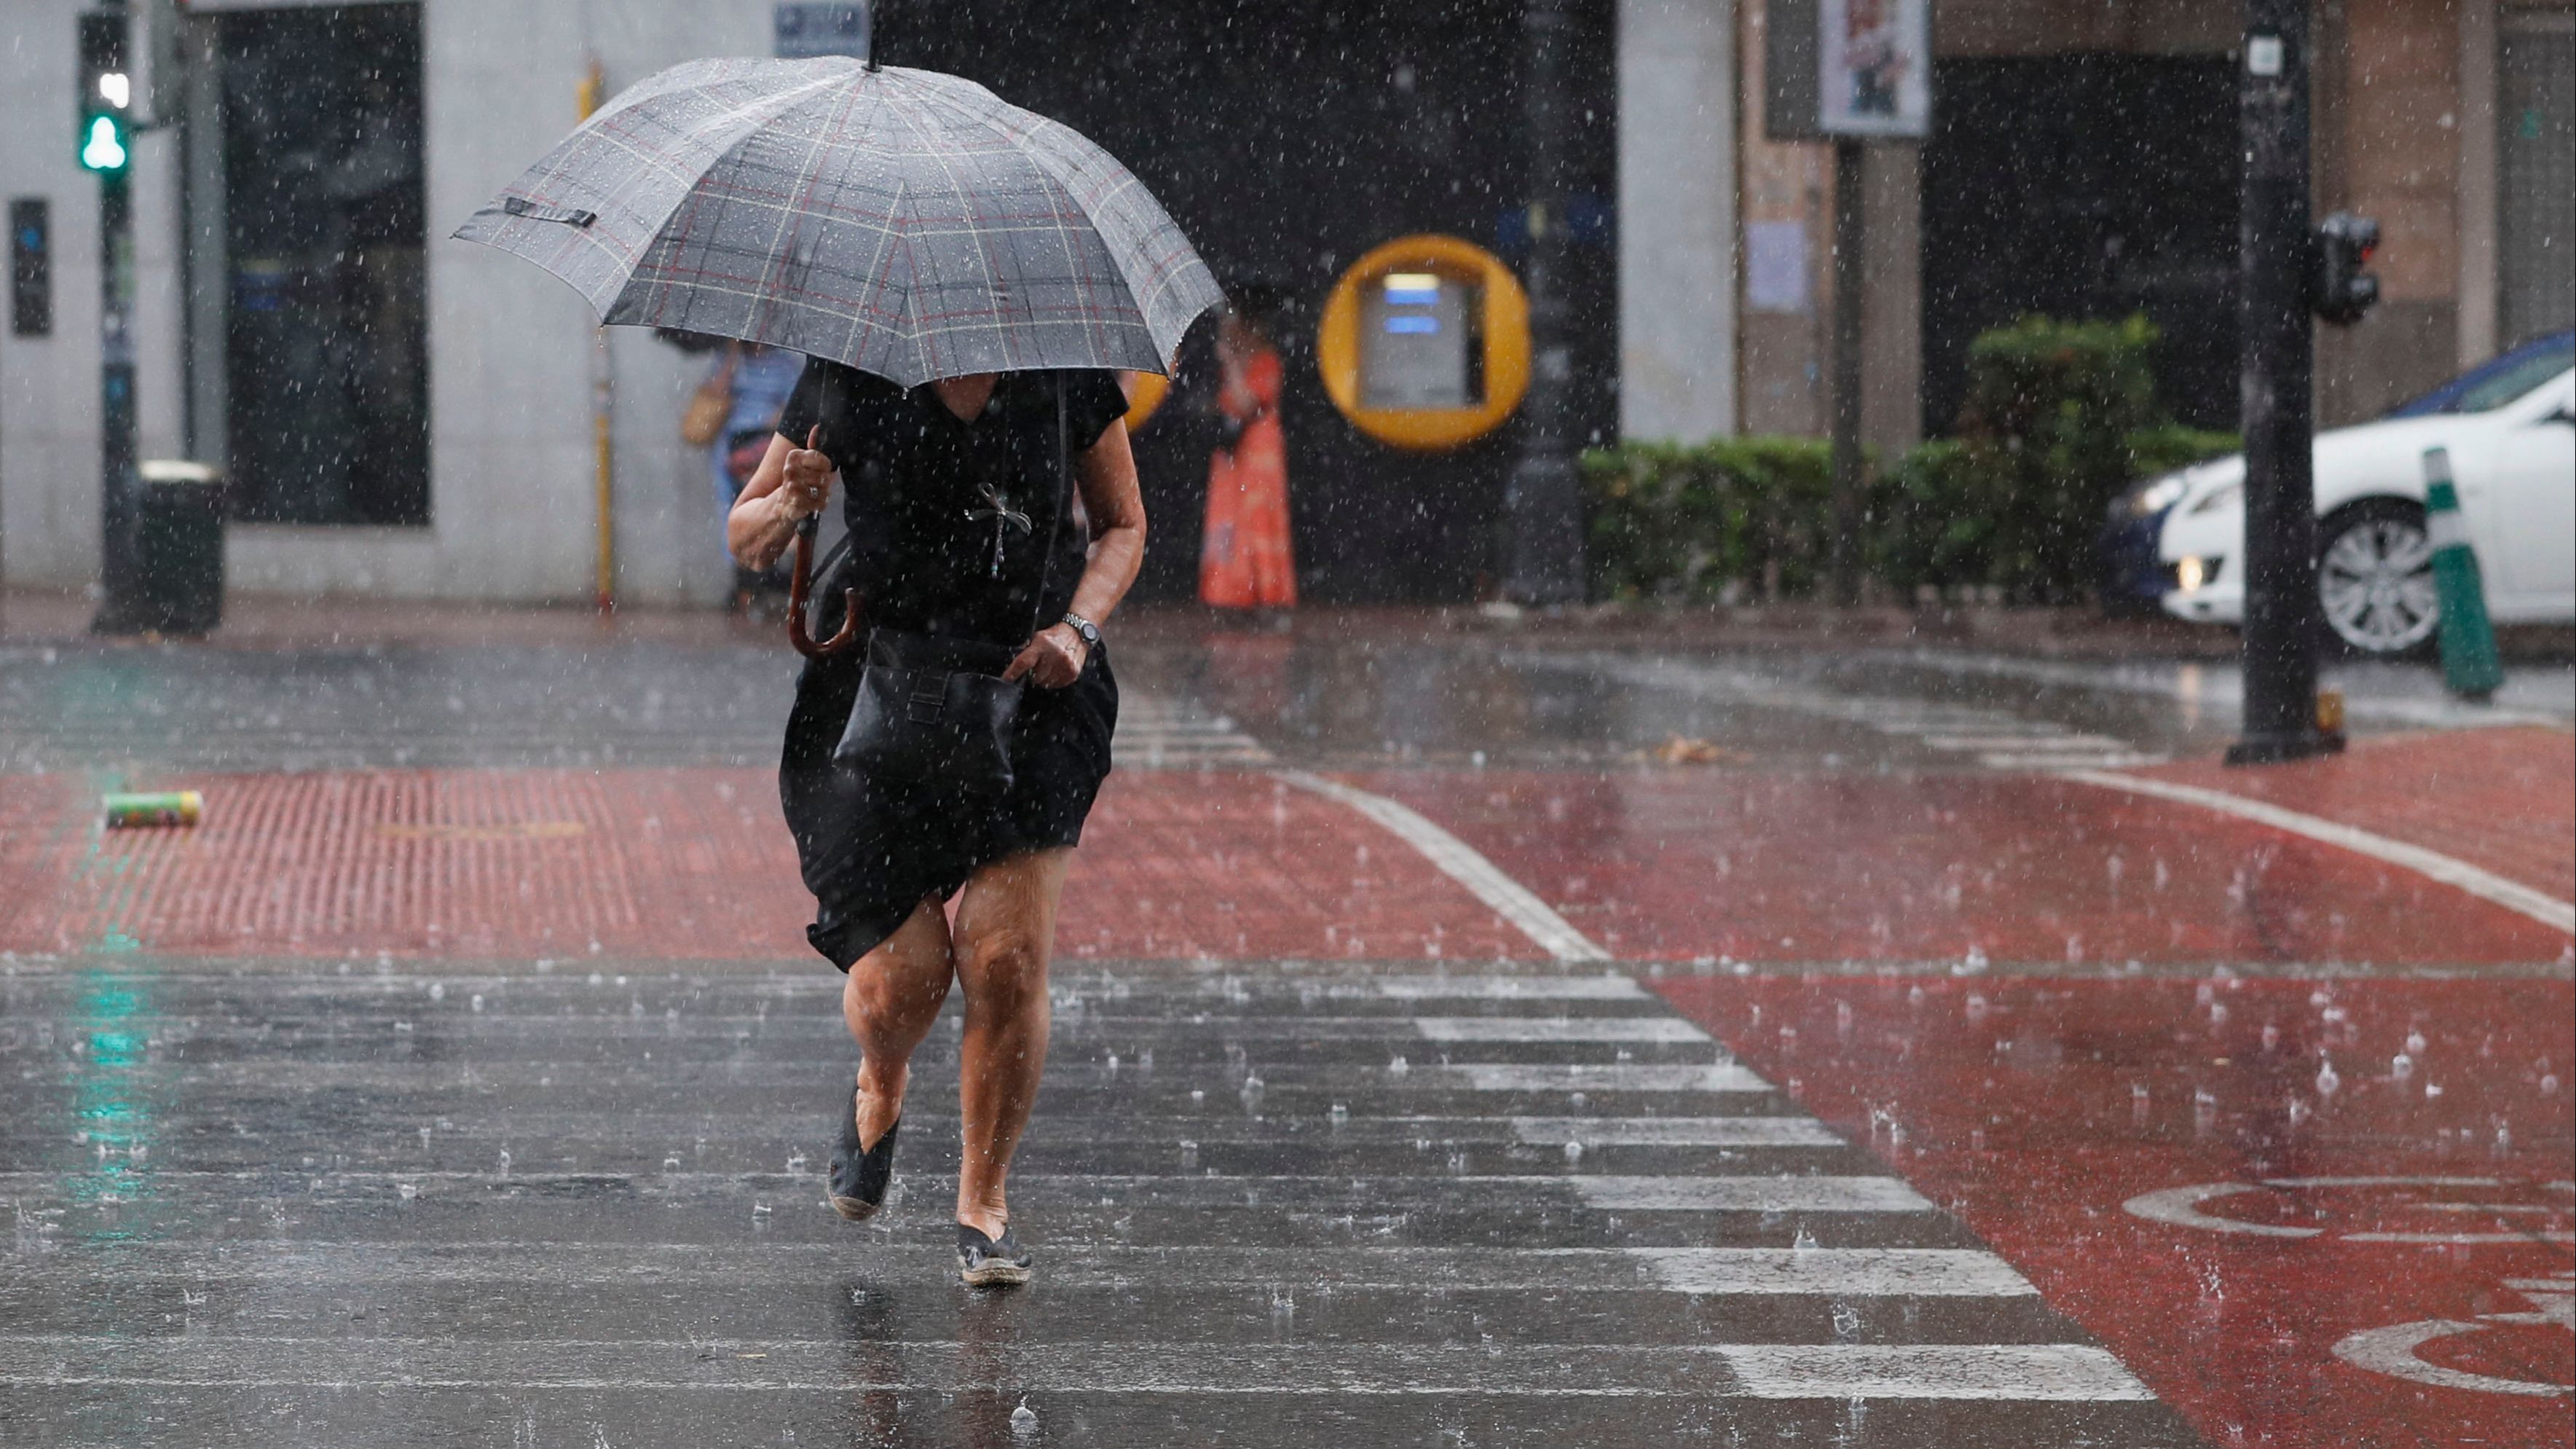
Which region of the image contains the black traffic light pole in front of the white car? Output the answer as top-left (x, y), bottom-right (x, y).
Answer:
top-left (2229, 0), bottom-right (2341, 766)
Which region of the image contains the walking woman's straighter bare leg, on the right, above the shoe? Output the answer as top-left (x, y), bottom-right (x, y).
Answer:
top-left (956, 848), bottom-right (1074, 1238)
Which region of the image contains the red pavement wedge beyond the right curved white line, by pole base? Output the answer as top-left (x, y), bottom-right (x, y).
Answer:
top-left (2135, 727), bottom-right (2576, 900)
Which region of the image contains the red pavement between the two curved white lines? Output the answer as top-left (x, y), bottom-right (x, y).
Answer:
top-left (1366, 769), bottom-right (2568, 965)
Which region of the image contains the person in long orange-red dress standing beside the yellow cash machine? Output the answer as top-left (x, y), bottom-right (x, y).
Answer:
top-left (1198, 288), bottom-right (1296, 608)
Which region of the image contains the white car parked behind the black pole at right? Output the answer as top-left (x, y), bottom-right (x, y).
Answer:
top-left (2146, 369), bottom-right (2576, 657)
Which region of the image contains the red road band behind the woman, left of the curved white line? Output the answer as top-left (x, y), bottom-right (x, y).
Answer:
top-left (0, 769), bottom-right (1533, 959)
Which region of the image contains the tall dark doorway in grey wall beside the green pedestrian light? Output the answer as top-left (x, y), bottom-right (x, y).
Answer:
top-left (214, 3), bottom-right (430, 526)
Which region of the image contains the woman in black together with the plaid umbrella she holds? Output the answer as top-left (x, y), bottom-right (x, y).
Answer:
top-left (459, 57), bottom-right (1224, 1284)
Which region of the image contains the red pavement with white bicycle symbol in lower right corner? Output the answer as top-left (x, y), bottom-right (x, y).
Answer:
top-left (1654, 975), bottom-right (2576, 1449)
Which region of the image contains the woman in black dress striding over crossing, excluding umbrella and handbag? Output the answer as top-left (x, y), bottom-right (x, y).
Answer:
top-left (732, 361), bottom-right (1143, 1284)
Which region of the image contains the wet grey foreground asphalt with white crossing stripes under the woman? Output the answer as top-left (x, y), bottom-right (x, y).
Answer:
top-left (0, 959), bottom-right (2195, 1446)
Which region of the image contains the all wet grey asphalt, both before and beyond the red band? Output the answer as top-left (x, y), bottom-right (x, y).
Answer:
top-left (0, 632), bottom-right (2576, 1449)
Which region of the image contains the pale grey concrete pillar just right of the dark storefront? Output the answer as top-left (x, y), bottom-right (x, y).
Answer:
top-left (1618, 0), bottom-right (1736, 441)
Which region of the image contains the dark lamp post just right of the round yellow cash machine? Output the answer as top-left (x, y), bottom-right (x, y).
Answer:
top-left (1505, 0), bottom-right (1584, 606)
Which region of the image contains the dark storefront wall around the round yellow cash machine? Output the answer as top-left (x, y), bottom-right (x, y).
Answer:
top-left (886, 0), bottom-right (1618, 601)
